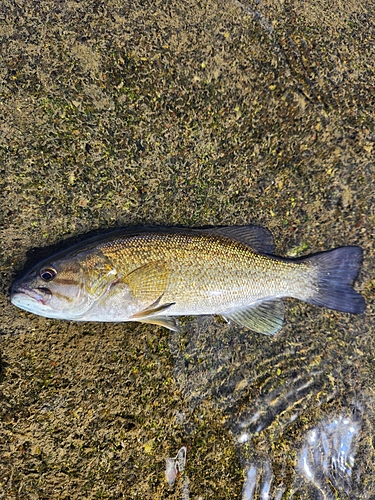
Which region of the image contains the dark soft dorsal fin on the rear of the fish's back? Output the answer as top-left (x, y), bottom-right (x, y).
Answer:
top-left (204, 225), bottom-right (274, 254)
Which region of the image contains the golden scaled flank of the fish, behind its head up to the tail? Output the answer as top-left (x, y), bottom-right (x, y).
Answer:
top-left (100, 234), bottom-right (306, 306)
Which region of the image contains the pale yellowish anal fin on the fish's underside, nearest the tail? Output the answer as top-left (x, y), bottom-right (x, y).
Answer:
top-left (223, 299), bottom-right (284, 335)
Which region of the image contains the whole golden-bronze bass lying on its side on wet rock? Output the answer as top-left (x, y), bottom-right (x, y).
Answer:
top-left (11, 225), bottom-right (366, 335)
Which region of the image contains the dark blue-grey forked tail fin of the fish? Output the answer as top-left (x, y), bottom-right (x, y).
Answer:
top-left (304, 246), bottom-right (366, 314)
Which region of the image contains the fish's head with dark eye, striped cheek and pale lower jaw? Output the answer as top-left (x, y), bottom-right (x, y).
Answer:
top-left (11, 255), bottom-right (108, 320)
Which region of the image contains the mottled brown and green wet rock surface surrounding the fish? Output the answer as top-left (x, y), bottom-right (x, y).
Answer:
top-left (0, 0), bottom-right (375, 499)
